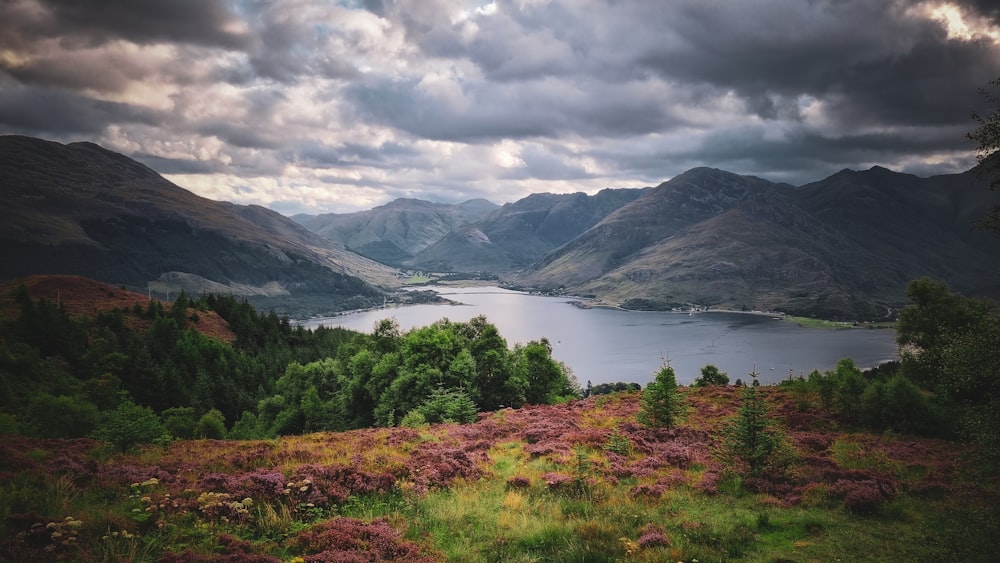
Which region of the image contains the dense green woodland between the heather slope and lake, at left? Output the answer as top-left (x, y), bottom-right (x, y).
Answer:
top-left (0, 287), bottom-right (580, 447)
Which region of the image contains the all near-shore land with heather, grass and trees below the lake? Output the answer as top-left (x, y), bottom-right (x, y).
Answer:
top-left (0, 278), bottom-right (1000, 562)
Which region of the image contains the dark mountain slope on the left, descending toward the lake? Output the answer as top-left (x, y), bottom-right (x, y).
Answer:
top-left (0, 136), bottom-right (391, 316)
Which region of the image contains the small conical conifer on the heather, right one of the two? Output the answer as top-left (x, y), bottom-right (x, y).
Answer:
top-left (723, 370), bottom-right (788, 476)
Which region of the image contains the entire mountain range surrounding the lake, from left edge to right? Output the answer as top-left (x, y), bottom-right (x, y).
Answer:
top-left (0, 136), bottom-right (1000, 320)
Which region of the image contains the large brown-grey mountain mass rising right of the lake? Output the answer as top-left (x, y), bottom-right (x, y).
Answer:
top-left (516, 167), bottom-right (1000, 319)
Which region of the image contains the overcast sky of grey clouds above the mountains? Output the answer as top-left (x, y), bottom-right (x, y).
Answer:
top-left (0, 0), bottom-right (1000, 214)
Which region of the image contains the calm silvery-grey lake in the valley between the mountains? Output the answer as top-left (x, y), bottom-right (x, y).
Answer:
top-left (299, 287), bottom-right (896, 386)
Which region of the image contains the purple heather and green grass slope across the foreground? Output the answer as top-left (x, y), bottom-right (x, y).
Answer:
top-left (0, 387), bottom-right (1000, 563)
